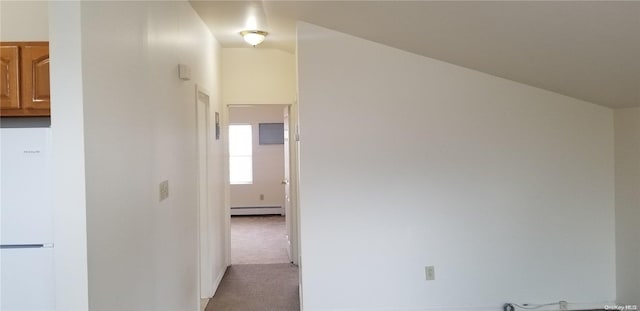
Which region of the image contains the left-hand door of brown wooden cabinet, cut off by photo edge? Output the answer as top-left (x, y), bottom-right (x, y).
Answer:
top-left (0, 46), bottom-right (20, 110)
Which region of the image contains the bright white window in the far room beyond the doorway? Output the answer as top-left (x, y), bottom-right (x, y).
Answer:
top-left (229, 124), bottom-right (253, 185)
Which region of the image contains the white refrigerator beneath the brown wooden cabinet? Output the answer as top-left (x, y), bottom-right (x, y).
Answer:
top-left (0, 128), bottom-right (55, 311)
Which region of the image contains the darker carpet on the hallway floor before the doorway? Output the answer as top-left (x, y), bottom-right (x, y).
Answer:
top-left (205, 263), bottom-right (300, 311)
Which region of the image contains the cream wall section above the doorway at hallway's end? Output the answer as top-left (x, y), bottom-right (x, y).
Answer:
top-left (222, 47), bottom-right (296, 104)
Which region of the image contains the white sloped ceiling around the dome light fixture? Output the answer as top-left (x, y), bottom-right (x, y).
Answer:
top-left (191, 0), bottom-right (640, 108)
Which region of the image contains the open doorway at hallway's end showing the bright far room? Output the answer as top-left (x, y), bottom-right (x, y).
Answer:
top-left (228, 105), bottom-right (294, 265)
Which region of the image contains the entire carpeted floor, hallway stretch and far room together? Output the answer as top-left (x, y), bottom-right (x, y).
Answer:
top-left (205, 215), bottom-right (300, 311)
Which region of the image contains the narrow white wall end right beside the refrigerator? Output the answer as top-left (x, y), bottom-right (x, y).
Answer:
top-left (48, 1), bottom-right (89, 310)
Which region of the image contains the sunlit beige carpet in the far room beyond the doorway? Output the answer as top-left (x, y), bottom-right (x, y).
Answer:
top-left (231, 215), bottom-right (290, 265)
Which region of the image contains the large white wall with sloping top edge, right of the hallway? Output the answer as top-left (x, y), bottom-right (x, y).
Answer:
top-left (297, 23), bottom-right (616, 311)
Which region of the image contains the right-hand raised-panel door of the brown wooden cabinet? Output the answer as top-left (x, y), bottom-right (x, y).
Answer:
top-left (22, 45), bottom-right (50, 110)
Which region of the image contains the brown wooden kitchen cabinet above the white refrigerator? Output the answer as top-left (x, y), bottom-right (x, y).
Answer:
top-left (0, 42), bottom-right (51, 117)
